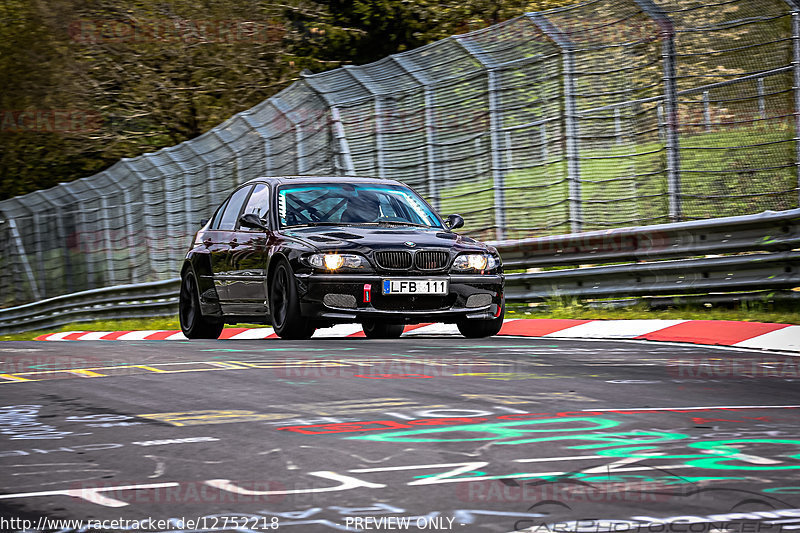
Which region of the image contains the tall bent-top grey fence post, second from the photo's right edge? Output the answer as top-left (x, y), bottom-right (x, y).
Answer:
top-left (634, 0), bottom-right (683, 222)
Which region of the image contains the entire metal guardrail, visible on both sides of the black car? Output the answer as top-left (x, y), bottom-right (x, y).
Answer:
top-left (0, 209), bottom-right (800, 334)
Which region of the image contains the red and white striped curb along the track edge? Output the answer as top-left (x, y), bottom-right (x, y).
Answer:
top-left (36, 319), bottom-right (800, 352)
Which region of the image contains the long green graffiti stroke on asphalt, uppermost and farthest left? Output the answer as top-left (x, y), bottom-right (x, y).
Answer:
top-left (347, 417), bottom-right (620, 444)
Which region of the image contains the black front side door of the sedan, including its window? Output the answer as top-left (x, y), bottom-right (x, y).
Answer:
top-left (228, 183), bottom-right (273, 315)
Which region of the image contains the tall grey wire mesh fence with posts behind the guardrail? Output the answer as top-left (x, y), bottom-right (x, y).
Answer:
top-left (0, 0), bottom-right (800, 306)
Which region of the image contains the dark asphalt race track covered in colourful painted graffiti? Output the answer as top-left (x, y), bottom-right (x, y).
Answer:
top-left (0, 336), bottom-right (800, 533)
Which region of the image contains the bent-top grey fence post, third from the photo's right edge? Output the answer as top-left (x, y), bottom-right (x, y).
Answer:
top-left (528, 13), bottom-right (584, 233)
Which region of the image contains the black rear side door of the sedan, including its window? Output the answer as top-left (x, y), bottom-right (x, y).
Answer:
top-left (208, 185), bottom-right (253, 304)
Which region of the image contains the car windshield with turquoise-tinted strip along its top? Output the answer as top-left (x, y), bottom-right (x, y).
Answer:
top-left (278, 183), bottom-right (442, 229)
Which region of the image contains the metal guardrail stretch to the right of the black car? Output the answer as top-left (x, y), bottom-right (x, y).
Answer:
top-left (495, 209), bottom-right (800, 302)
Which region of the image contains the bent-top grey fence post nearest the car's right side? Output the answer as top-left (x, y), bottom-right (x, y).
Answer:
top-left (453, 36), bottom-right (506, 240)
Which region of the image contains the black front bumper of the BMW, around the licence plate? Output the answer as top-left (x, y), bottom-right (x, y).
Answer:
top-left (295, 274), bottom-right (504, 324)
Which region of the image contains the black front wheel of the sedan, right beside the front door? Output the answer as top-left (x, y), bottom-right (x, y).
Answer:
top-left (269, 259), bottom-right (317, 340)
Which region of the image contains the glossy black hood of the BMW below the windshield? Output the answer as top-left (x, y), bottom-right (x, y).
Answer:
top-left (282, 222), bottom-right (490, 251)
